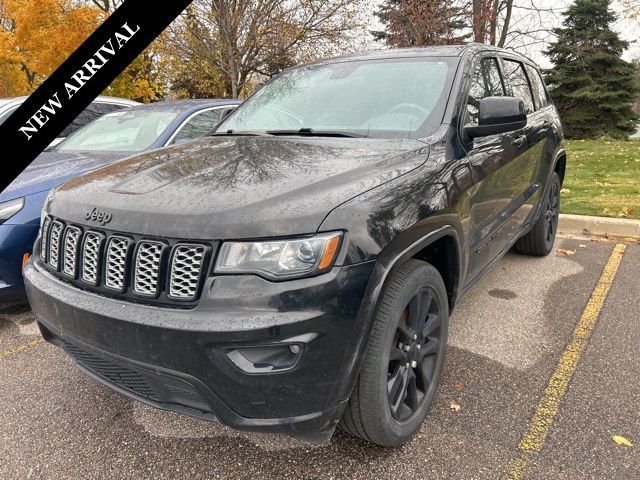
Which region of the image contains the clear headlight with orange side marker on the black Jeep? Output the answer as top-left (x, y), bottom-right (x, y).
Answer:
top-left (215, 232), bottom-right (342, 280)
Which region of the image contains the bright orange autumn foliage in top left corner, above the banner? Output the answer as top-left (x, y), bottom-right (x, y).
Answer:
top-left (0, 0), bottom-right (104, 97)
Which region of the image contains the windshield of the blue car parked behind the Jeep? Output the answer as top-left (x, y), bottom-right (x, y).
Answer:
top-left (56, 110), bottom-right (180, 152)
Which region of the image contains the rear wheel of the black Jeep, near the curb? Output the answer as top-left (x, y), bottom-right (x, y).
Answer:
top-left (515, 172), bottom-right (560, 257)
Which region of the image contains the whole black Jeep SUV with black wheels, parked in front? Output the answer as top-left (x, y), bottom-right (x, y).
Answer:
top-left (25, 45), bottom-right (565, 446)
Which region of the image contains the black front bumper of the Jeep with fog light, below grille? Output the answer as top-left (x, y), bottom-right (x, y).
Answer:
top-left (25, 261), bottom-right (374, 439)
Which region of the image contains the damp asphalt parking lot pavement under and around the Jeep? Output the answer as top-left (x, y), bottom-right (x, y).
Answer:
top-left (0, 238), bottom-right (640, 479)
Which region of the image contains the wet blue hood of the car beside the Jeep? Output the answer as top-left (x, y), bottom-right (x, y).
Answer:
top-left (0, 150), bottom-right (130, 202)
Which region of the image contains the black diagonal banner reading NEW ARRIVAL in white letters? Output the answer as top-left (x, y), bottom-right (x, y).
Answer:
top-left (0, 0), bottom-right (192, 192)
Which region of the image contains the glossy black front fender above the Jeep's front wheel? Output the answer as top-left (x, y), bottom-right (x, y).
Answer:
top-left (319, 148), bottom-right (468, 406)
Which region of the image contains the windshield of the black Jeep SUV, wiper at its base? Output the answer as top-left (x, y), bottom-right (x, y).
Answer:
top-left (217, 57), bottom-right (458, 138)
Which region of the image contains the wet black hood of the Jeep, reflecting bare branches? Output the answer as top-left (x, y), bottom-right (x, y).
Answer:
top-left (47, 136), bottom-right (428, 240)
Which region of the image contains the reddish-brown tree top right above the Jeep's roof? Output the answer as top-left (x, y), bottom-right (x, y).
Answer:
top-left (371, 0), bottom-right (470, 47)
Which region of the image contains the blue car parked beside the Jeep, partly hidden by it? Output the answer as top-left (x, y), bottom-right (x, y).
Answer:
top-left (0, 100), bottom-right (240, 302)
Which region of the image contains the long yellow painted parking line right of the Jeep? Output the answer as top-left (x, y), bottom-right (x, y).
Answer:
top-left (500, 244), bottom-right (627, 480)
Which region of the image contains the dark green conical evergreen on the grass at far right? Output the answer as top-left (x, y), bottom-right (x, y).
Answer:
top-left (545, 0), bottom-right (639, 138)
